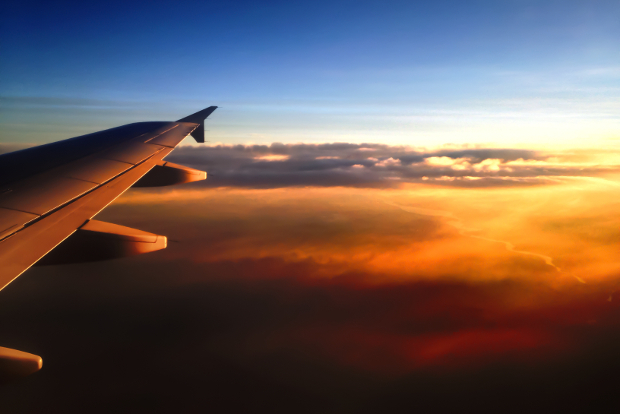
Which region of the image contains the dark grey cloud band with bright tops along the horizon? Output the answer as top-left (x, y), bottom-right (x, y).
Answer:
top-left (163, 143), bottom-right (617, 188)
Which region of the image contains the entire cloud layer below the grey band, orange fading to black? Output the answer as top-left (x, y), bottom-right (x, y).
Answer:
top-left (0, 183), bottom-right (620, 412)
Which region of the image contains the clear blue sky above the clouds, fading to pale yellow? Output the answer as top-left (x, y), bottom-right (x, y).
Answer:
top-left (0, 0), bottom-right (620, 147)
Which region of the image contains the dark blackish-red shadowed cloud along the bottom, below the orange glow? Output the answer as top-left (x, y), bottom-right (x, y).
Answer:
top-left (0, 256), bottom-right (620, 413)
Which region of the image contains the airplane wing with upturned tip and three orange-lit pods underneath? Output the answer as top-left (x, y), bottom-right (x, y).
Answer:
top-left (0, 106), bottom-right (217, 382)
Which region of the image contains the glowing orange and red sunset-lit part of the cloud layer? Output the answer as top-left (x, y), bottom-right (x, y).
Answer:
top-left (94, 161), bottom-right (620, 375)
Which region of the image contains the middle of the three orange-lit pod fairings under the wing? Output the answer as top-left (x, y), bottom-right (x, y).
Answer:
top-left (37, 220), bottom-right (168, 265)
